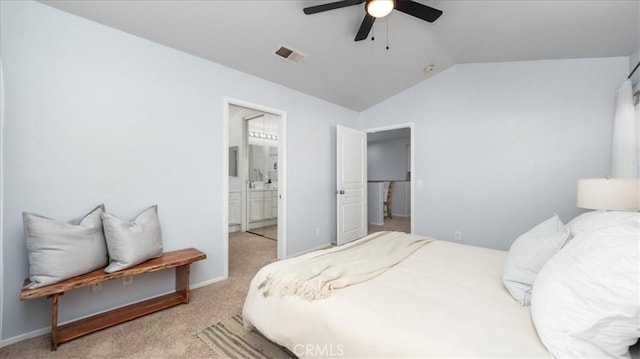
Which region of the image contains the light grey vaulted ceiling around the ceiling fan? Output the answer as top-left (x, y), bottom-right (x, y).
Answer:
top-left (43, 0), bottom-right (640, 111)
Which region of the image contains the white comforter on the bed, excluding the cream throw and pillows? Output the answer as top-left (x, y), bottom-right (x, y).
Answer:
top-left (243, 241), bottom-right (549, 358)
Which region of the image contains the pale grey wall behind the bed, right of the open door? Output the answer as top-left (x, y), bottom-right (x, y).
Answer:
top-left (361, 57), bottom-right (629, 249)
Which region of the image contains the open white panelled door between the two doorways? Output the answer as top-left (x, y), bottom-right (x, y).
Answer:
top-left (336, 126), bottom-right (367, 245)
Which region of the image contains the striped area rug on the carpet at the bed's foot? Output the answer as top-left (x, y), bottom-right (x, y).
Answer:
top-left (198, 314), bottom-right (296, 358)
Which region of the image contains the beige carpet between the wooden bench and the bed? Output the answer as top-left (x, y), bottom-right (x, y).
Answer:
top-left (0, 232), bottom-right (277, 359)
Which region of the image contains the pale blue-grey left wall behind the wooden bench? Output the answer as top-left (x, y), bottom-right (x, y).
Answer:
top-left (0, 1), bottom-right (358, 339)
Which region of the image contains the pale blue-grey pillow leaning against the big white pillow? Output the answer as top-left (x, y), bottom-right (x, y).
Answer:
top-left (502, 215), bottom-right (569, 306)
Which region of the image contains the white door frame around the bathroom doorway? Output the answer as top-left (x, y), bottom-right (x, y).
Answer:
top-left (221, 96), bottom-right (287, 279)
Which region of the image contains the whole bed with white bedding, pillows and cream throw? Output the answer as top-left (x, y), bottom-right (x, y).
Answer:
top-left (243, 211), bottom-right (640, 358)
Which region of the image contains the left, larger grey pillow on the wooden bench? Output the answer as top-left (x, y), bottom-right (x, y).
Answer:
top-left (22, 204), bottom-right (108, 288)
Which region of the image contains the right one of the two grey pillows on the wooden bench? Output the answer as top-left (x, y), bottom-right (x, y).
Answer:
top-left (102, 206), bottom-right (162, 273)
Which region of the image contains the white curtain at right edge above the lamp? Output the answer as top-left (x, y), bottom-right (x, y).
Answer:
top-left (611, 80), bottom-right (638, 178)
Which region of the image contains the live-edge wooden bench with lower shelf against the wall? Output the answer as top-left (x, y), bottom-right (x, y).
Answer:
top-left (20, 248), bottom-right (207, 350)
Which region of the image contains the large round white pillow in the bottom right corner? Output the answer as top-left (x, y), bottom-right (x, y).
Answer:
top-left (531, 222), bottom-right (640, 358)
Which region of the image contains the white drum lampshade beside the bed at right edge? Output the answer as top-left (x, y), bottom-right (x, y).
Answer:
top-left (577, 178), bottom-right (640, 211)
